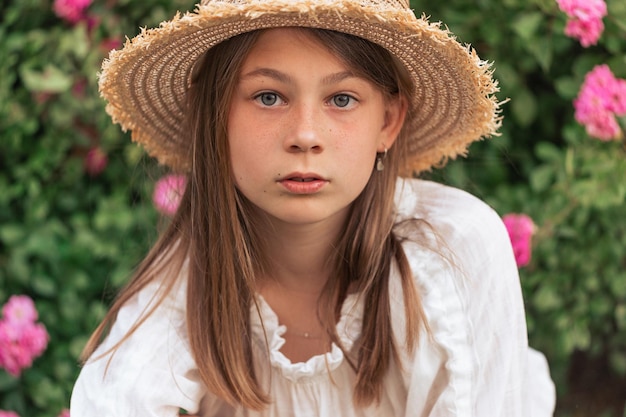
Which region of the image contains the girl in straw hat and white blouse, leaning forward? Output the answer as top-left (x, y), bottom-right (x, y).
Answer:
top-left (72, 0), bottom-right (554, 417)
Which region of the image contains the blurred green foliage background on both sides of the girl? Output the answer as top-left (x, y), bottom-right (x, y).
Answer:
top-left (0, 0), bottom-right (626, 417)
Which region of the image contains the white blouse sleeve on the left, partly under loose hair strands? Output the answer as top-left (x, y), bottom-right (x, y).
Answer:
top-left (70, 274), bottom-right (205, 417)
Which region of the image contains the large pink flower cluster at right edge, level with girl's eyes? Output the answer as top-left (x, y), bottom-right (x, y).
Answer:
top-left (574, 65), bottom-right (626, 140)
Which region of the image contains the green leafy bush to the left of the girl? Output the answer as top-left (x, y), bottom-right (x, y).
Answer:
top-left (0, 0), bottom-right (192, 417)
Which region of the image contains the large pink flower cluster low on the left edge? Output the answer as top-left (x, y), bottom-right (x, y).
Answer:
top-left (0, 296), bottom-right (49, 376)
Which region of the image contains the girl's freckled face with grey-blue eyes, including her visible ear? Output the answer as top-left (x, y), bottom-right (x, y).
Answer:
top-left (228, 29), bottom-right (406, 226)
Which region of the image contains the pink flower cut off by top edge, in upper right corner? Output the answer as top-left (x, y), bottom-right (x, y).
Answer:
top-left (556, 0), bottom-right (607, 48)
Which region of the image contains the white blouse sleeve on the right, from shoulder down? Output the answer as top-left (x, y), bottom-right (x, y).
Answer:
top-left (392, 181), bottom-right (553, 417)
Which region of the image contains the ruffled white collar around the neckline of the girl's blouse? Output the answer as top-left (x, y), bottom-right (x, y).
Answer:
top-left (250, 294), bottom-right (363, 382)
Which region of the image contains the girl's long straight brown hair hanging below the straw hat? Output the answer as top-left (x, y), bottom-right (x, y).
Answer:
top-left (83, 29), bottom-right (427, 410)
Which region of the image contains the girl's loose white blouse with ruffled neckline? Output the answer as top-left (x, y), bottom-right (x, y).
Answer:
top-left (71, 180), bottom-right (555, 417)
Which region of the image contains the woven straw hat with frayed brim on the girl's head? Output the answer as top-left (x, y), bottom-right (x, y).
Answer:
top-left (99, 0), bottom-right (501, 175)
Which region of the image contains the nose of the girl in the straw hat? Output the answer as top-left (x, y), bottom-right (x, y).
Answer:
top-left (285, 104), bottom-right (323, 153)
